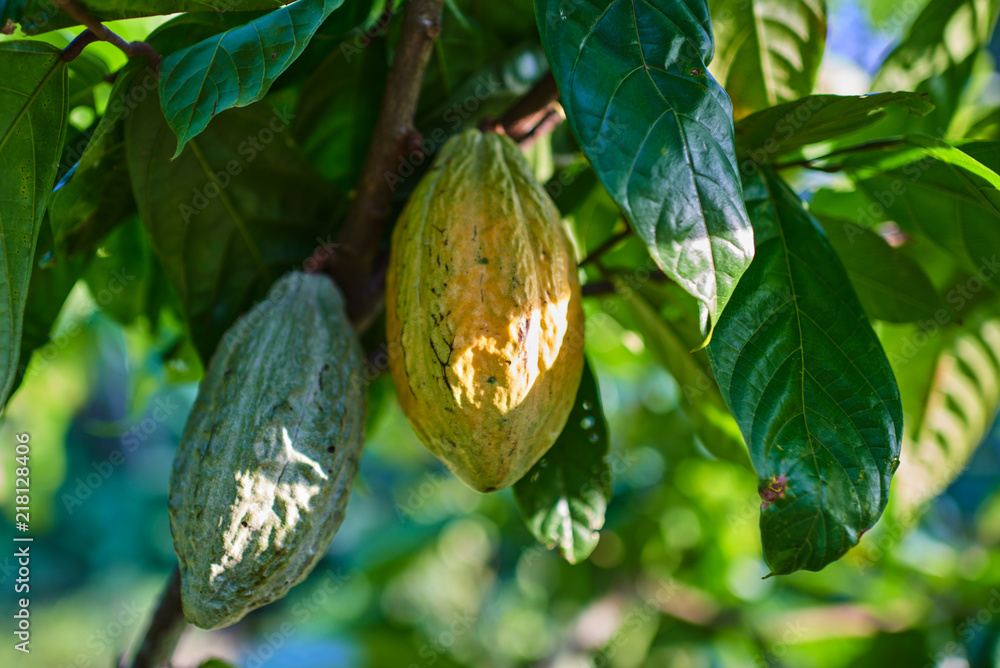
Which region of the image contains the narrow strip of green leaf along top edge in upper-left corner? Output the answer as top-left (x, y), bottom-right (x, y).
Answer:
top-left (0, 0), bottom-right (285, 35)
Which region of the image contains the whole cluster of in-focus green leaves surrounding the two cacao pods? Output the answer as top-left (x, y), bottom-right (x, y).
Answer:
top-left (0, 0), bottom-right (1000, 596)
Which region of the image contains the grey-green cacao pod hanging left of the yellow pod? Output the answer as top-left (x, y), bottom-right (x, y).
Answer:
top-left (170, 272), bottom-right (365, 629)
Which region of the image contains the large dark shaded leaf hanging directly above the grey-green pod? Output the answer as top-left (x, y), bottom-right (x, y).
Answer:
top-left (125, 82), bottom-right (336, 361)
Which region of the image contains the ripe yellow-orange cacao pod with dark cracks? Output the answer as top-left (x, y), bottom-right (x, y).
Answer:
top-left (386, 130), bottom-right (583, 492)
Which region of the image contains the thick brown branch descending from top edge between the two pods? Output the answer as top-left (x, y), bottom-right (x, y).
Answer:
top-left (317, 0), bottom-right (444, 330)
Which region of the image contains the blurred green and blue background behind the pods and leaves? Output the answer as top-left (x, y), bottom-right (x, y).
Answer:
top-left (0, 0), bottom-right (1000, 668)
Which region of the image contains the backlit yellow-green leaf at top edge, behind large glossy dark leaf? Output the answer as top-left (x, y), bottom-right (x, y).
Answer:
top-left (710, 0), bottom-right (826, 118)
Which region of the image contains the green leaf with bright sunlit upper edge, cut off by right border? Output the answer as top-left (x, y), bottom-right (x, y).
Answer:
top-left (844, 135), bottom-right (1000, 288)
